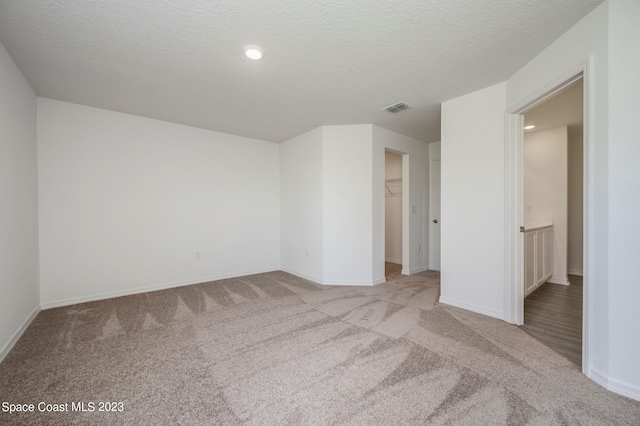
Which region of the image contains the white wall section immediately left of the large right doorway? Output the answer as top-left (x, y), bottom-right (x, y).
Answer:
top-left (440, 83), bottom-right (506, 318)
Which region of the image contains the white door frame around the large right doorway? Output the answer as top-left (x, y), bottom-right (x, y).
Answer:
top-left (504, 59), bottom-right (592, 372)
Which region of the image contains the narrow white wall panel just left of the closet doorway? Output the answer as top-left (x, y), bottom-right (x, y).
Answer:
top-left (322, 125), bottom-right (372, 285)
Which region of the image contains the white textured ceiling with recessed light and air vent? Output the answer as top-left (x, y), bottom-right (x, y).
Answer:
top-left (0, 0), bottom-right (602, 142)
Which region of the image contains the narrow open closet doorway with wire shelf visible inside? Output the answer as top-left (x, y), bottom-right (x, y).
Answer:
top-left (384, 149), bottom-right (403, 280)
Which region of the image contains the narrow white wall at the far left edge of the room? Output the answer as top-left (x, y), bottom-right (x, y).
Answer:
top-left (0, 44), bottom-right (40, 361)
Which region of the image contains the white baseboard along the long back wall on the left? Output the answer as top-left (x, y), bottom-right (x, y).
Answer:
top-left (41, 267), bottom-right (280, 309)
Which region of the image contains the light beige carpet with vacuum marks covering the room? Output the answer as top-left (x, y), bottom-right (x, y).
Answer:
top-left (0, 272), bottom-right (640, 425)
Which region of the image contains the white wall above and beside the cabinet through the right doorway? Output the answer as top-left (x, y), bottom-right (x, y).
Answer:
top-left (523, 126), bottom-right (569, 284)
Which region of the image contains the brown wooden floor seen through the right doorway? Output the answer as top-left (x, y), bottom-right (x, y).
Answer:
top-left (520, 275), bottom-right (582, 367)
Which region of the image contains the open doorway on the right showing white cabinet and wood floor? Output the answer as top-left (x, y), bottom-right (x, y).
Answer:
top-left (522, 79), bottom-right (584, 365)
